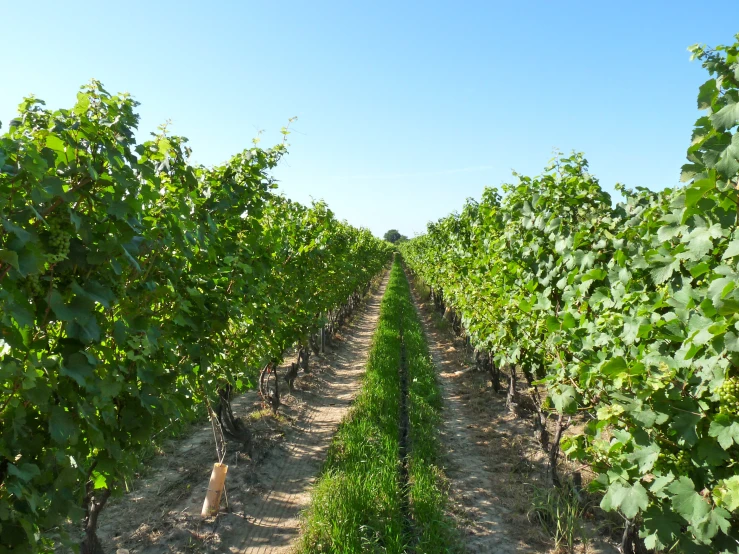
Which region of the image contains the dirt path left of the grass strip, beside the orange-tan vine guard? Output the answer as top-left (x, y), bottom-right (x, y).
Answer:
top-left (99, 275), bottom-right (388, 554)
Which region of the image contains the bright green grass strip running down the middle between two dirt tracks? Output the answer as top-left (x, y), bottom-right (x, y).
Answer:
top-left (300, 261), bottom-right (457, 554)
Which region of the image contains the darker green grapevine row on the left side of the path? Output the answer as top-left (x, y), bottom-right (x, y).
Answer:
top-left (0, 81), bottom-right (390, 553)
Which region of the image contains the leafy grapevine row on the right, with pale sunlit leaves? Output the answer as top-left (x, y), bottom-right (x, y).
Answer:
top-left (400, 35), bottom-right (739, 553)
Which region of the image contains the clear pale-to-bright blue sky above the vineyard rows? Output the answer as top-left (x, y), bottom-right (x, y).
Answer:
top-left (0, 0), bottom-right (739, 236)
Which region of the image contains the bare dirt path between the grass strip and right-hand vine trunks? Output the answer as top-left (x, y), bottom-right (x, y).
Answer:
top-left (404, 278), bottom-right (548, 554)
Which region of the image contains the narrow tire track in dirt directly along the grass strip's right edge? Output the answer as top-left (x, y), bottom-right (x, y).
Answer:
top-left (411, 272), bottom-right (548, 554)
